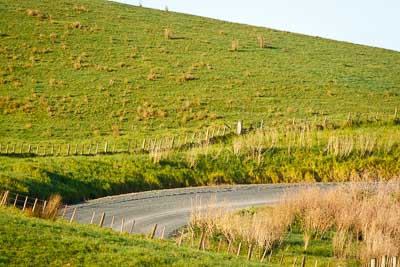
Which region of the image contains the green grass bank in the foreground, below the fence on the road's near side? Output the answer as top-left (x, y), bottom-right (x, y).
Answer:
top-left (0, 208), bottom-right (264, 266)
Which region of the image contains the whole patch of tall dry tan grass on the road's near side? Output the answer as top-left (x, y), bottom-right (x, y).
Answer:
top-left (191, 180), bottom-right (400, 262)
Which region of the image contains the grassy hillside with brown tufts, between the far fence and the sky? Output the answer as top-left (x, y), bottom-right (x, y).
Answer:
top-left (0, 0), bottom-right (400, 142)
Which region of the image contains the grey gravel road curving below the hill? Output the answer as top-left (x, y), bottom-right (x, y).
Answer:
top-left (65, 183), bottom-right (336, 237)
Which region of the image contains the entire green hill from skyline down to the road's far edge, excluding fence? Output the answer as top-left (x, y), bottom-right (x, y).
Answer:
top-left (0, 0), bottom-right (400, 202)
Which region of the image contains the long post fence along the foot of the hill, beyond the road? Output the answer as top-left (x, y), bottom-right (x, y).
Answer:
top-left (0, 112), bottom-right (400, 157)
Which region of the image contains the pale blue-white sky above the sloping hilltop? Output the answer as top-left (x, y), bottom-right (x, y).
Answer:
top-left (116, 0), bottom-right (400, 51)
